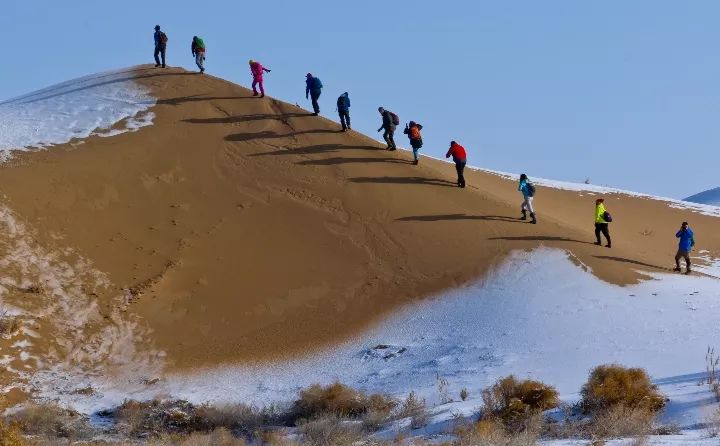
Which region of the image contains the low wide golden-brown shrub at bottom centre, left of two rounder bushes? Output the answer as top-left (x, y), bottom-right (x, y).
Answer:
top-left (292, 382), bottom-right (397, 421)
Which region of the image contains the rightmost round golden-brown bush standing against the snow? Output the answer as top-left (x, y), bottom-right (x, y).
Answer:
top-left (581, 364), bottom-right (665, 413)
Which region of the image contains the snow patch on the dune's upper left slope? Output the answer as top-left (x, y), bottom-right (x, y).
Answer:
top-left (0, 71), bottom-right (155, 157)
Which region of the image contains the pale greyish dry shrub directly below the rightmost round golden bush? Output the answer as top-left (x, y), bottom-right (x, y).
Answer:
top-left (589, 405), bottom-right (655, 439)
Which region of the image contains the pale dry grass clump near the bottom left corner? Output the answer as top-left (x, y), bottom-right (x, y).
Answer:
top-left (8, 403), bottom-right (93, 440)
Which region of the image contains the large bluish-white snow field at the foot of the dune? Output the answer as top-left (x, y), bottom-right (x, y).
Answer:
top-left (48, 248), bottom-right (720, 440)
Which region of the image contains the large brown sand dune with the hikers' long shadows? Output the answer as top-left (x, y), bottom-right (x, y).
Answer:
top-left (0, 67), bottom-right (720, 380)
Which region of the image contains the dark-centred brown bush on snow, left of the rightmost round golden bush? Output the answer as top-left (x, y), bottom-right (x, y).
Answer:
top-left (482, 375), bottom-right (559, 432)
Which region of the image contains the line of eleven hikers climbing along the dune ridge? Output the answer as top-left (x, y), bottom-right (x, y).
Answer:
top-left (153, 25), bottom-right (695, 274)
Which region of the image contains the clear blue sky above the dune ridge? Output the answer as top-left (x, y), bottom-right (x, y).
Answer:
top-left (0, 0), bottom-right (720, 198)
